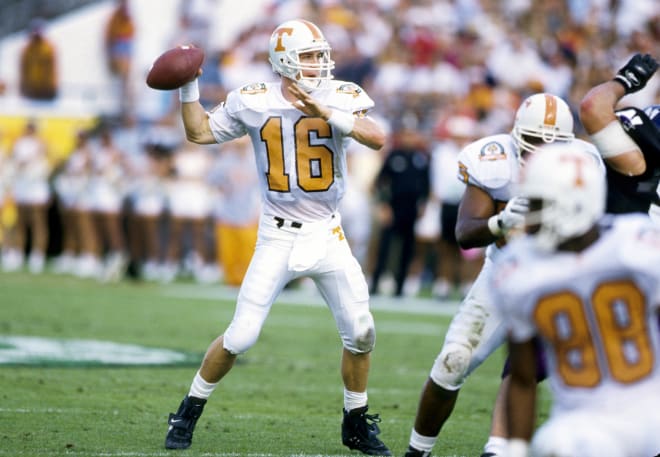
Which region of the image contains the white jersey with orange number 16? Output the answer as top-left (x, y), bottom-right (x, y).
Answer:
top-left (209, 81), bottom-right (374, 222)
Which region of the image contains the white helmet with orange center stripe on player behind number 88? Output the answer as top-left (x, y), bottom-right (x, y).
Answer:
top-left (511, 93), bottom-right (575, 159)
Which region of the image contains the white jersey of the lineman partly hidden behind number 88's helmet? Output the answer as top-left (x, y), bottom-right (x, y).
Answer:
top-left (458, 133), bottom-right (605, 256)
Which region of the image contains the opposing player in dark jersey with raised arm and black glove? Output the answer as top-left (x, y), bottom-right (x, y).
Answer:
top-left (580, 54), bottom-right (660, 223)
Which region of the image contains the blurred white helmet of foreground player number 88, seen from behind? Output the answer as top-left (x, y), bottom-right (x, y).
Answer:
top-left (518, 143), bottom-right (607, 251)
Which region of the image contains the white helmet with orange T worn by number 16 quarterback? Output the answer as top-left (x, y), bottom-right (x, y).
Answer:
top-left (268, 19), bottom-right (335, 90)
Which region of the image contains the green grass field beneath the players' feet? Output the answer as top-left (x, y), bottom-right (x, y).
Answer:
top-left (0, 274), bottom-right (548, 457)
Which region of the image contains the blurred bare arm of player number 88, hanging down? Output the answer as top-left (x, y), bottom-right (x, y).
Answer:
top-left (506, 339), bottom-right (536, 455)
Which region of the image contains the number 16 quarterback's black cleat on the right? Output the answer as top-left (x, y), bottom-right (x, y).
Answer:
top-left (341, 406), bottom-right (392, 455)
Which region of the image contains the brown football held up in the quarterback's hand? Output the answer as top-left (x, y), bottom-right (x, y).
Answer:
top-left (147, 46), bottom-right (204, 90)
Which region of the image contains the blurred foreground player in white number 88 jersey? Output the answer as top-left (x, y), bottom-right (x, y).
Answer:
top-left (491, 144), bottom-right (660, 457)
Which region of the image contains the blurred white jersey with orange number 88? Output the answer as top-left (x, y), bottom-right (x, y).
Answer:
top-left (491, 215), bottom-right (660, 414)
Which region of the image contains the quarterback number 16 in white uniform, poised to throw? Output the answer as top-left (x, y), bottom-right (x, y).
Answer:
top-left (165, 20), bottom-right (391, 455)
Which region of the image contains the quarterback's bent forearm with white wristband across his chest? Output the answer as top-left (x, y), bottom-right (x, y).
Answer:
top-left (288, 84), bottom-right (385, 149)
